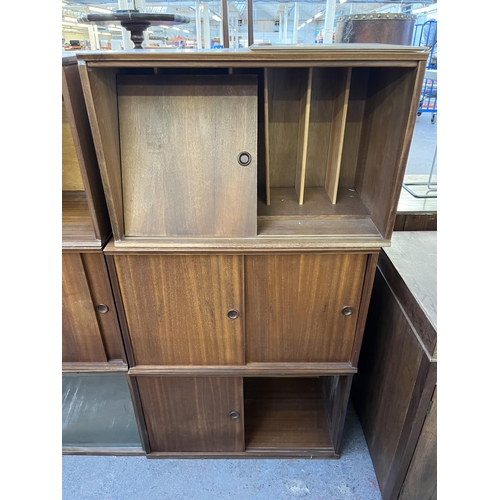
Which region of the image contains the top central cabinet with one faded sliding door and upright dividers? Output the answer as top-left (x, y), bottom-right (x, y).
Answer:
top-left (76, 44), bottom-right (427, 252)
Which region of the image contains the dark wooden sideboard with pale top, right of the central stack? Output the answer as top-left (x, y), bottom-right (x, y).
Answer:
top-left (353, 231), bottom-right (438, 500)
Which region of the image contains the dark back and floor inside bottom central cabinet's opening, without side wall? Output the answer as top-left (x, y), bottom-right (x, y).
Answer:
top-left (244, 377), bottom-right (333, 454)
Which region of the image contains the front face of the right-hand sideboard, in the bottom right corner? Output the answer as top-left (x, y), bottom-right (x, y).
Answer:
top-left (398, 386), bottom-right (437, 500)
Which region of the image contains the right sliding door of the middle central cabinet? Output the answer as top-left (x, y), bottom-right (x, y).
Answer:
top-left (245, 254), bottom-right (366, 363)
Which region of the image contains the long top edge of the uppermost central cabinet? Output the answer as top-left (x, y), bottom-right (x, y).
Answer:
top-left (75, 43), bottom-right (428, 65)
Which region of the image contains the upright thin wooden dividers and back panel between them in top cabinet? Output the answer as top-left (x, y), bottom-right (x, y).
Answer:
top-left (264, 67), bottom-right (351, 205)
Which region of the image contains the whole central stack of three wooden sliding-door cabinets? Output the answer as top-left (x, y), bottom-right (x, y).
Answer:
top-left (76, 45), bottom-right (426, 458)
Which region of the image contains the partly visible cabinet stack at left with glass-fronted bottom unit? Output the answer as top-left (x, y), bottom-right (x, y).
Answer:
top-left (61, 54), bottom-right (141, 453)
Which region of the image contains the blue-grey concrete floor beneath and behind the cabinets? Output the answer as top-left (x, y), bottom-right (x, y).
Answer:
top-left (62, 102), bottom-right (437, 500)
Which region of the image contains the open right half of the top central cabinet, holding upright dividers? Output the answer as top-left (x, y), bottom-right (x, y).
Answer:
top-left (258, 63), bottom-right (417, 243)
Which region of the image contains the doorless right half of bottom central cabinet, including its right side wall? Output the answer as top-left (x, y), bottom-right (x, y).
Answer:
top-left (244, 376), bottom-right (351, 457)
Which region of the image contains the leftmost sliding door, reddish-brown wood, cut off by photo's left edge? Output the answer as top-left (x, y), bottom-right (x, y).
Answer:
top-left (62, 253), bottom-right (107, 362)
